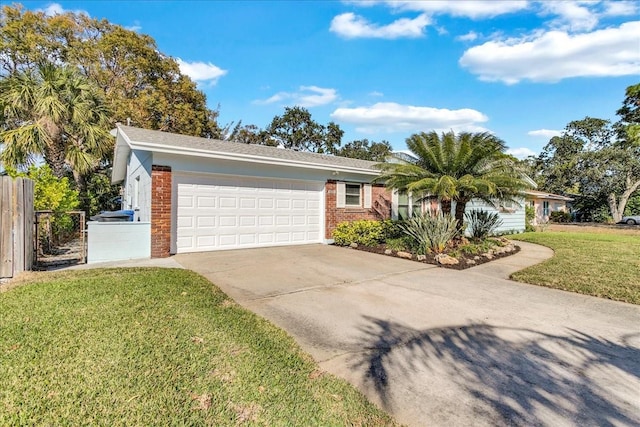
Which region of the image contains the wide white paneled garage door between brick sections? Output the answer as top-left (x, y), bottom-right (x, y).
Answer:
top-left (174, 175), bottom-right (324, 253)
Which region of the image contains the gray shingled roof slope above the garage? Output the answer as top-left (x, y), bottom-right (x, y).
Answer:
top-left (118, 125), bottom-right (378, 170)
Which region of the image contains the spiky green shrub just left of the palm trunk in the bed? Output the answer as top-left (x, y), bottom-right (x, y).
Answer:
top-left (400, 213), bottom-right (458, 254)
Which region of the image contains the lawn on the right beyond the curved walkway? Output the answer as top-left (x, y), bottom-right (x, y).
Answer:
top-left (510, 227), bottom-right (640, 304)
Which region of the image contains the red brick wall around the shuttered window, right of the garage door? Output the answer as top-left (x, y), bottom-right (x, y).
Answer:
top-left (325, 181), bottom-right (391, 239)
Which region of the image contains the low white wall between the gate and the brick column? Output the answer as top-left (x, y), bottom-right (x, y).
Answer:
top-left (87, 221), bottom-right (151, 264)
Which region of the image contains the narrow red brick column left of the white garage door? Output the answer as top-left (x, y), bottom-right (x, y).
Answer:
top-left (151, 165), bottom-right (172, 258)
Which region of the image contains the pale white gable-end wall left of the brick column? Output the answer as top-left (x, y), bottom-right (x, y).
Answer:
top-left (122, 150), bottom-right (153, 222)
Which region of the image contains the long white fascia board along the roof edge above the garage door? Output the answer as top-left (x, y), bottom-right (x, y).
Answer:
top-left (125, 140), bottom-right (380, 176)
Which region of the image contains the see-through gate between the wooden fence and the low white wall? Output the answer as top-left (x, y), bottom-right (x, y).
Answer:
top-left (35, 211), bottom-right (87, 270)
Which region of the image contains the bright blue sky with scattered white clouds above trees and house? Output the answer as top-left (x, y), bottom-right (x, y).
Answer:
top-left (23, 0), bottom-right (640, 157)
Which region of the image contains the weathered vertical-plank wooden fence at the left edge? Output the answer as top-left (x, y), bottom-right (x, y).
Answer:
top-left (0, 176), bottom-right (35, 278)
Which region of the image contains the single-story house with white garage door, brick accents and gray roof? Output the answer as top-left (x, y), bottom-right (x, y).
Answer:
top-left (112, 125), bottom-right (524, 257)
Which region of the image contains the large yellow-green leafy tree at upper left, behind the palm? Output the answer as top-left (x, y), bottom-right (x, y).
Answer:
top-left (0, 6), bottom-right (222, 138)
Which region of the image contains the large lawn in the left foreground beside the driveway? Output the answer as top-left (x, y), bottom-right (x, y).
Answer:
top-left (0, 269), bottom-right (394, 426)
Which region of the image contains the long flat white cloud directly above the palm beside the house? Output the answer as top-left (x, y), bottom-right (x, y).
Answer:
top-left (331, 102), bottom-right (488, 133)
